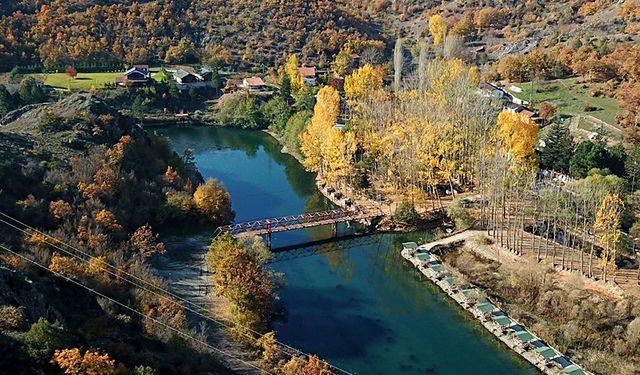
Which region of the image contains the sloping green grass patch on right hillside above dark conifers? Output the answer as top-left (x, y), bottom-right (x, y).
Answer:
top-left (506, 78), bottom-right (624, 126)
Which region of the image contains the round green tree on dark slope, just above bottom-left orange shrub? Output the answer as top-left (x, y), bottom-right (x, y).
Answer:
top-left (22, 318), bottom-right (73, 363)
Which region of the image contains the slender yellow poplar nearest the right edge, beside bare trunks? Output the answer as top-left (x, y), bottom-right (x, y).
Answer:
top-left (594, 194), bottom-right (624, 282)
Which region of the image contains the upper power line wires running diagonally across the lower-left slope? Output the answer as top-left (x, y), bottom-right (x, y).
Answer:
top-left (0, 211), bottom-right (351, 375)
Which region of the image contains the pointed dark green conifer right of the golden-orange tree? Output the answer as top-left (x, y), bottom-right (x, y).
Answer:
top-left (540, 123), bottom-right (573, 172)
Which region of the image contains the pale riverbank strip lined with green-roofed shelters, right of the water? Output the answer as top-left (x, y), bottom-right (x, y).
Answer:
top-left (401, 230), bottom-right (587, 375)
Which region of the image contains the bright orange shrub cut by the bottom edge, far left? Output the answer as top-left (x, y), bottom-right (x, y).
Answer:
top-left (51, 348), bottom-right (116, 375)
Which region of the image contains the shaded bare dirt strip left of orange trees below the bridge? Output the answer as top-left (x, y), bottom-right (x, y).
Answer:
top-left (154, 237), bottom-right (260, 374)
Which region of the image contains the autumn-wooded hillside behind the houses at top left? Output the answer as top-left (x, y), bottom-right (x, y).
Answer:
top-left (0, 0), bottom-right (380, 70)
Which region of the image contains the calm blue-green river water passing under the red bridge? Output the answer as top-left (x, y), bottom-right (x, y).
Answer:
top-left (156, 127), bottom-right (538, 375)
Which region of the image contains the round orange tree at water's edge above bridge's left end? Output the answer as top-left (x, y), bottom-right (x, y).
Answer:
top-left (193, 178), bottom-right (235, 224)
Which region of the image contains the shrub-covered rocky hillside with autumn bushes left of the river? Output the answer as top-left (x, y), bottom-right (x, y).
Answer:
top-left (0, 94), bottom-right (238, 374)
